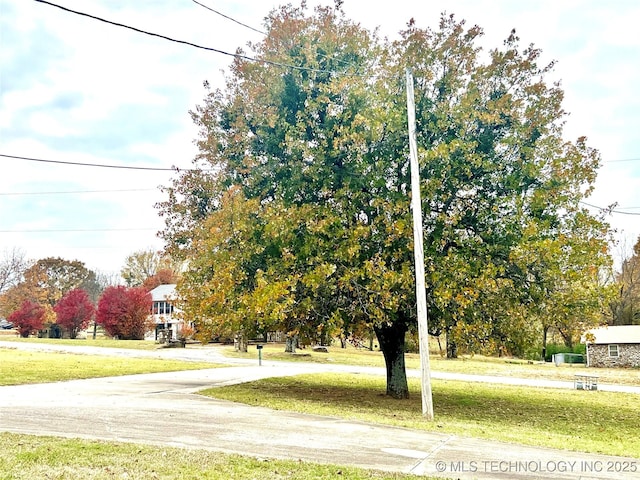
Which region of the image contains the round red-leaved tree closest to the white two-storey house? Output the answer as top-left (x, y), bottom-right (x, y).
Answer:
top-left (96, 285), bottom-right (153, 340)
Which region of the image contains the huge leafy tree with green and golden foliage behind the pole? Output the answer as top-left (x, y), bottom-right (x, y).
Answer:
top-left (160, 6), bottom-right (607, 398)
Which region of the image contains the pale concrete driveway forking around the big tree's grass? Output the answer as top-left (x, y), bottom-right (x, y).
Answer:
top-left (0, 342), bottom-right (640, 479)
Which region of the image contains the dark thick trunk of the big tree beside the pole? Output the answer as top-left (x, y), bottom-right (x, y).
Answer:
top-left (374, 322), bottom-right (409, 399)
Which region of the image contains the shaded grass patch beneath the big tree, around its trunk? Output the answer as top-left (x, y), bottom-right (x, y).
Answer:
top-left (201, 374), bottom-right (640, 458)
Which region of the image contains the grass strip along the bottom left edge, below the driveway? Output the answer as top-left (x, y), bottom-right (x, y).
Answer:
top-left (0, 433), bottom-right (428, 480)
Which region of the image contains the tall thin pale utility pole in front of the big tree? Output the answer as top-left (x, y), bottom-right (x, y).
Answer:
top-left (407, 68), bottom-right (433, 420)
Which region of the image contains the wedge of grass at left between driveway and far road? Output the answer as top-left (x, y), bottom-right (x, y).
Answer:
top-left (0, 348), bottom-right (216, 385)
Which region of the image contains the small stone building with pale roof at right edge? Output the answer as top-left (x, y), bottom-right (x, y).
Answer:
top-left (582, 325), bottom-right (640, 367)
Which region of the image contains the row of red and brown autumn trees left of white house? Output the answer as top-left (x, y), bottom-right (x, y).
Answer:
top-left (0, 249), bottom-right (177, 339)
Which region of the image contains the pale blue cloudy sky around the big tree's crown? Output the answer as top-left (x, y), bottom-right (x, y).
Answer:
top-left (0, 0), bottom-right (640, 272)
